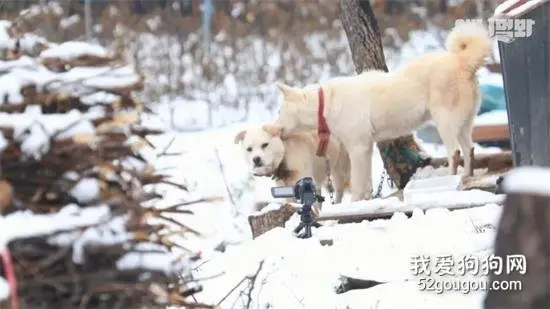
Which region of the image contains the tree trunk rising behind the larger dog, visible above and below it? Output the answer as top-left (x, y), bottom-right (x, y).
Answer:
top-left (340, 0), bottom-right (431, 189)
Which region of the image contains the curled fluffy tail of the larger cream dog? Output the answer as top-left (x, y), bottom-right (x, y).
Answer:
top-left (445, 22), bottom-right (492, 70)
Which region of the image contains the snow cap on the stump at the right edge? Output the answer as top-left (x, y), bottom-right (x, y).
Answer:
top-left (502, 166), bottom-right (550, 196)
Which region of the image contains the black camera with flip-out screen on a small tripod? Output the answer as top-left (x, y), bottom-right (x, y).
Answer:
top-left (271, 177), bottom-right (325, 238)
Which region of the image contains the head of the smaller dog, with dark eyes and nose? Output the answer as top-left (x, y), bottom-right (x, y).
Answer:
top-left (235, 124), bottom-right (285, 176)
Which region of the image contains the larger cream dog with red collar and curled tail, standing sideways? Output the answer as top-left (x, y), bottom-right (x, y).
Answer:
top-left (277, 23), bottom-right (491, 201)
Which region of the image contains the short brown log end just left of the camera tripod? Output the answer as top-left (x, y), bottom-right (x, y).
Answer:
top-left (248, 204), bottom-right (297, 238)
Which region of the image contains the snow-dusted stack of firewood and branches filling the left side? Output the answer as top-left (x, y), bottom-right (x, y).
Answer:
top-left (0, 21), bottom-right (213, 309)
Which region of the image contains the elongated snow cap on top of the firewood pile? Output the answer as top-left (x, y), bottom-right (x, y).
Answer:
top-left (40, 41), bottom-right (109, 61)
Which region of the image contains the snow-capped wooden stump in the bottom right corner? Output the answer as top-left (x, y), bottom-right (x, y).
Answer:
top-left (485, 167), bottom-right (550, 309)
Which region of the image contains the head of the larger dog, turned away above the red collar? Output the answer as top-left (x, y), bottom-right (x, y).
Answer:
top-left (277, 82), bottom-right (307, 134)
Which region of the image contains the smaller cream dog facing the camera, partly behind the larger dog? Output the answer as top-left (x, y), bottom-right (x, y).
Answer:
top-left (235, 125), bottom-right (350, 203)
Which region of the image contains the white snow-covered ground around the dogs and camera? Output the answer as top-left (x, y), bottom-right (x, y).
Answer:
top-left (149, 112), bottom-right (508, 308)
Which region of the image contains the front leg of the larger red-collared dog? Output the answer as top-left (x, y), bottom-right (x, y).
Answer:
top-left (346, 143), bottom-right (372, 201)
